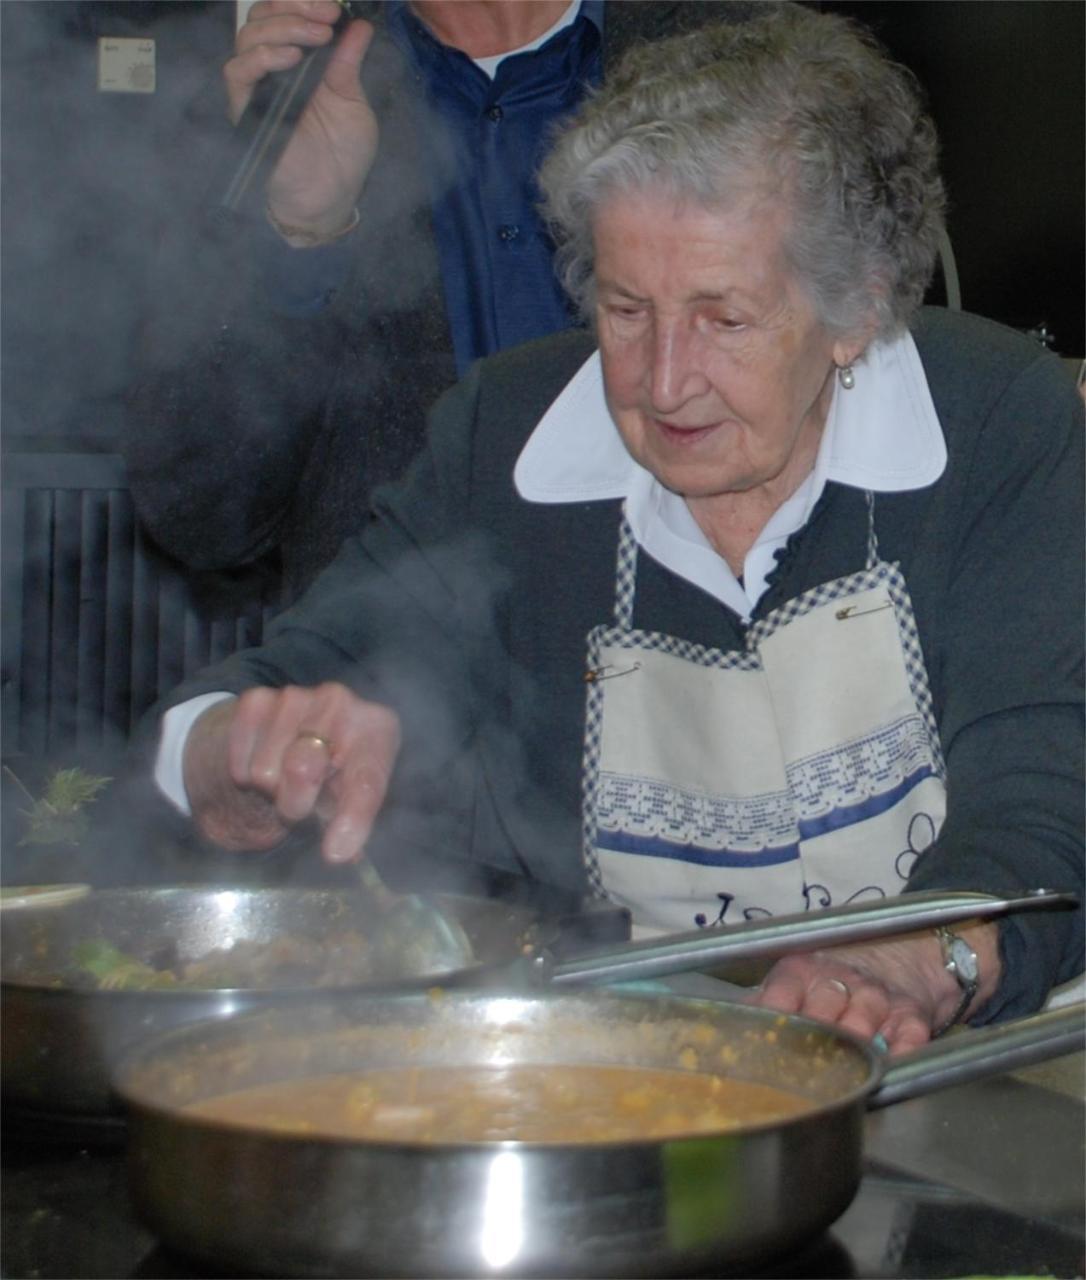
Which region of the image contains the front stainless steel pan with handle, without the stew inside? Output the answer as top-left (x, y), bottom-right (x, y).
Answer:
top-left (115, 991), bottom-right (1083, 1276)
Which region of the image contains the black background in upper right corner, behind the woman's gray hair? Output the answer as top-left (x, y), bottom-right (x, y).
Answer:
top-left (820, 0), bottom-right (1086, 356)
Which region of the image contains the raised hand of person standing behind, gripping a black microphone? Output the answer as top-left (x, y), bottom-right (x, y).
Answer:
top-left (223, 0), bottom-right (378, 236)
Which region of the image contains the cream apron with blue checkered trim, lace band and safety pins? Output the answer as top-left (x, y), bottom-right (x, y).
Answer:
top-left (584, 494), bottom-right (946, 933)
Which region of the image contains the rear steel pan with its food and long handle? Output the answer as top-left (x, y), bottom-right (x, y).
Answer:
top-left (0, 887), bottom-right (1076, 1116)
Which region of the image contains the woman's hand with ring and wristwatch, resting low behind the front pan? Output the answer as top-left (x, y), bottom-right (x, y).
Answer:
top-left (750, 924), bottom-right (999, 1055)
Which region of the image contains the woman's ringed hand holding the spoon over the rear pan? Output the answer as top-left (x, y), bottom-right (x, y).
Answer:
top-left (184, 681), bottom-right (400, 863)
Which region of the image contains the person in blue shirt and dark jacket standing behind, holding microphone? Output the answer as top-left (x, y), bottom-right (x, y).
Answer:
top-left (126, 0), bottom-right (762, 599)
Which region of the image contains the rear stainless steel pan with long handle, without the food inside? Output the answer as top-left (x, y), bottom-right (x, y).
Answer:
top-left (0, 888), bottom-right (1076, 1116)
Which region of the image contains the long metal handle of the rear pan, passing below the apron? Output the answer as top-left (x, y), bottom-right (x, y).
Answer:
top-left (548, 890), bottom-right (1078, 986)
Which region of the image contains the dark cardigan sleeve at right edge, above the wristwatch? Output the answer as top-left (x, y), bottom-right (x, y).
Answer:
top-left (909, 335), bottom-right (1083, 1023)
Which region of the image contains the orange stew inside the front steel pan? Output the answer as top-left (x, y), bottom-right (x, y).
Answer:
top-left (187, 1065), bottom-right (812, 1143)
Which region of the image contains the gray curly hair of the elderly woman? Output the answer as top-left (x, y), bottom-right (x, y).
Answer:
top-left (539, 4), bottom-right (945, 337)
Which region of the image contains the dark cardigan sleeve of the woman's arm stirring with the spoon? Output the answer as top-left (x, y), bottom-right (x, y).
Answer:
top-left (129, 360), bottom-right (502, 859)
